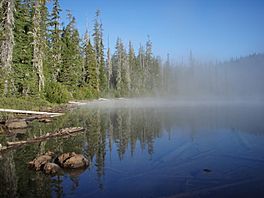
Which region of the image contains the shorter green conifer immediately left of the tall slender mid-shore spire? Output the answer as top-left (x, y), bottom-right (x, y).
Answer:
top-left (83, 31), bottom-right (99, 95)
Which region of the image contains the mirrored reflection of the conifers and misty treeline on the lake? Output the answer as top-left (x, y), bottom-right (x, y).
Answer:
top-left (0, 103), bottom-right (264, 197)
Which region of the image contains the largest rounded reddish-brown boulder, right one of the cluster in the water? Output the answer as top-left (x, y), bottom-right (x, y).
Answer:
top-left (58, 152), bottom-right (89, 169)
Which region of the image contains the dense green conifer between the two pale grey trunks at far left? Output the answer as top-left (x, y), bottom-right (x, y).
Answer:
top-left (13, 0), bottom-right (37, 95)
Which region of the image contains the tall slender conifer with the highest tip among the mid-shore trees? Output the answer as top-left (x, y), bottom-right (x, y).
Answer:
top-left (93, 10), bottom-right (107, 92)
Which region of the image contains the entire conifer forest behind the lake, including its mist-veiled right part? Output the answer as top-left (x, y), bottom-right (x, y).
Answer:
top-left (0, 0), bottom-right (264, 106)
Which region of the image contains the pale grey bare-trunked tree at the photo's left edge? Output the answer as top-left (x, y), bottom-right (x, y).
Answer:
top-left (0, 0), bottom-right (15, 95)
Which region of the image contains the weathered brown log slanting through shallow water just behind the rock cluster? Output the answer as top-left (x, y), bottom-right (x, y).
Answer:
top-left (0, 127), bottom-right (84, 151)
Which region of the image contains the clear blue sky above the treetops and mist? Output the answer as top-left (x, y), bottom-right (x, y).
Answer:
top-left (49, 0), bottom-right (264, 61)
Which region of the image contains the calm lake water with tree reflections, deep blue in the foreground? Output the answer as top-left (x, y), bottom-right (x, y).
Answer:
top-left (0, 100), bottom-right (264, 197)
